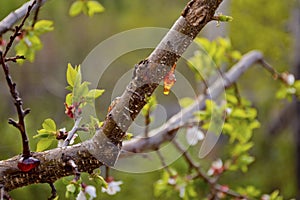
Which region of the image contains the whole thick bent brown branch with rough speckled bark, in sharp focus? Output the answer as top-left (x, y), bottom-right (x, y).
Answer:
top-left (0, 0), bottom-right (222, 191)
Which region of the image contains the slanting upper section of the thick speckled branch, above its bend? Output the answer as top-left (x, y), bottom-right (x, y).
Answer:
top-left (96, 0), bottom-right (222, 144)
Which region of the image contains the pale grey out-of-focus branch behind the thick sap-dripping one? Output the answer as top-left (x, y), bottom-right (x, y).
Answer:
top-left (121, 51), bottom-right (263, 156)
